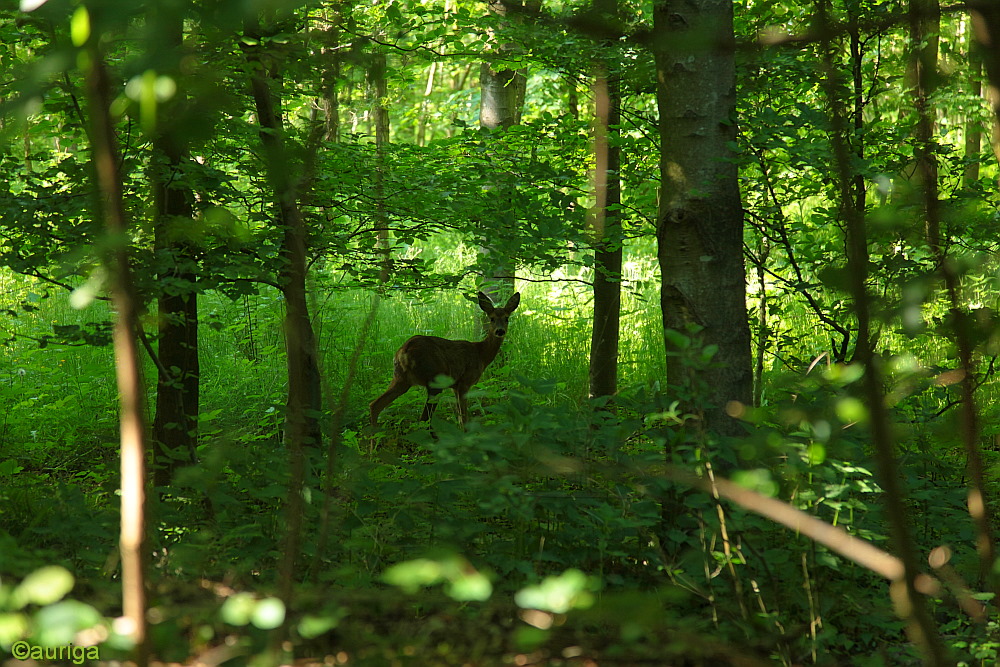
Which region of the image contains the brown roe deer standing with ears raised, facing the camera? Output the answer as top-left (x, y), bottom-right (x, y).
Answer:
top-left (368, 292), bottom-right (521, 427)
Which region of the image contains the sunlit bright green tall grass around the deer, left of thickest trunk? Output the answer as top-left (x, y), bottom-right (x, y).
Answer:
top-left (0, 260), bottom-right (663, 447)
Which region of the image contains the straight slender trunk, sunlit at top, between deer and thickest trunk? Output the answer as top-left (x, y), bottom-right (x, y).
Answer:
top-left (590, 60), bottom-right (622, 396)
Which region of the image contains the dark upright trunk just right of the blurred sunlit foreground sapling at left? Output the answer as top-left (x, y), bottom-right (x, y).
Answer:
top-left (150, 9), bottom-right (200, 486)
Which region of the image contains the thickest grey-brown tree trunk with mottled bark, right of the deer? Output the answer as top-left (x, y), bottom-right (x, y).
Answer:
top-left (653, 0), bottom-right (752, 435)
